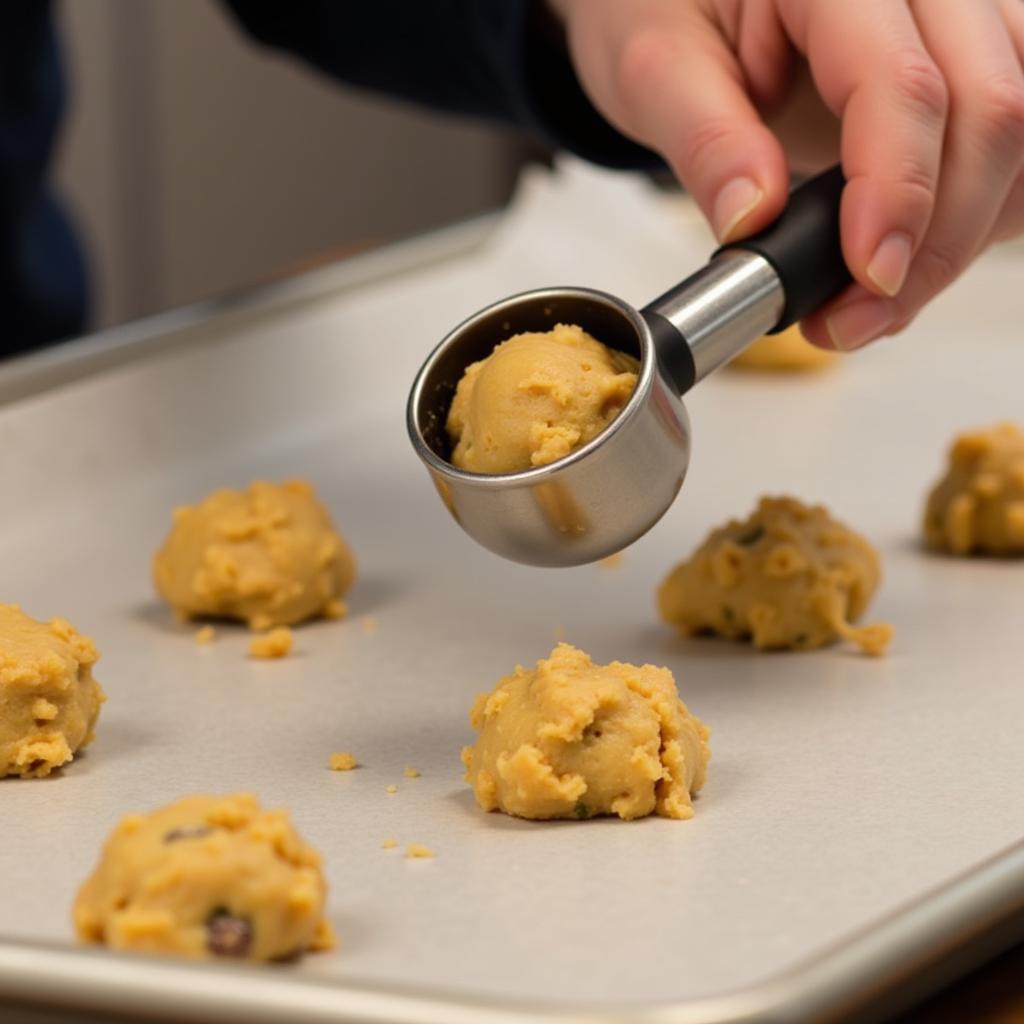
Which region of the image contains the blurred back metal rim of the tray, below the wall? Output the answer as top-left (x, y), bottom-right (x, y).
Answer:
top-left (0, 213), bottom-right (500, 408)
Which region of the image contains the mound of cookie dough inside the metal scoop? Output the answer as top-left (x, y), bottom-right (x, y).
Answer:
top-left (447, 324), bottom-right (637, 473)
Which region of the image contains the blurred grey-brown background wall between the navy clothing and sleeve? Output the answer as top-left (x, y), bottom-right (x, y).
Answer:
top-left (57, 0), bottom-right (527, 328)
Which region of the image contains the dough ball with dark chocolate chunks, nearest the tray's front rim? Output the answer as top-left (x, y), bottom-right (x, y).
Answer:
top-left (74, 793), bottom-right (335, 961)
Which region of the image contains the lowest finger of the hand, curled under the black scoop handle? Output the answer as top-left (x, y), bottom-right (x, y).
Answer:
top-left (807, 0), bottom-right (1024, 349)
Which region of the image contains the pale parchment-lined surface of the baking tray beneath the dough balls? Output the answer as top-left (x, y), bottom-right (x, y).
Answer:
top-left (0, 159), bottom-right (1024, 1020)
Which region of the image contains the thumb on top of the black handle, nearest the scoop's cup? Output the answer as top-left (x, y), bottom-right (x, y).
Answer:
top-left (617, 19), bottom-right (788, 242)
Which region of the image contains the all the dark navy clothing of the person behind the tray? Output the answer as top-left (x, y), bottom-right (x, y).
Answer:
top-left (0, 0), bottom-right (657, 357)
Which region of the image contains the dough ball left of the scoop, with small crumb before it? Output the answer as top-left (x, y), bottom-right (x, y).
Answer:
top-left (153, 480), bottom-right (355, 630)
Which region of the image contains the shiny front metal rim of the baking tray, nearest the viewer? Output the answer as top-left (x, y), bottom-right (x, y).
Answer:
top-left (0, 842), bottom-right (1024, 1024)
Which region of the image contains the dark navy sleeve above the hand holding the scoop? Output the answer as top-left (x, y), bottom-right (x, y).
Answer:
top-left (224, 0), bottom-right (658, 168)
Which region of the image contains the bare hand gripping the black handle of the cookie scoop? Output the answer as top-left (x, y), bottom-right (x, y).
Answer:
top-left (549, 0), bottom-right (1024, 349)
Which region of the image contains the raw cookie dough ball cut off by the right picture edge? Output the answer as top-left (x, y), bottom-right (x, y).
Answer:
top-left (925, 423), bottom-right (1024, 555)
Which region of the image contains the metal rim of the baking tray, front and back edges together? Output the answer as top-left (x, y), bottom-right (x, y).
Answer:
top-left (0, 207), bottom-right (1024, 1024)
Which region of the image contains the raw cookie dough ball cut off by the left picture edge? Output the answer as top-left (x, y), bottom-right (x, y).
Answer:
top-left (0, 604), bottom-right (106, 778)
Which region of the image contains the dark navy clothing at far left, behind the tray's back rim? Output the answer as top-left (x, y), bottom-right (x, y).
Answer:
top-left (0, 0), bottom-right (86, 358)
